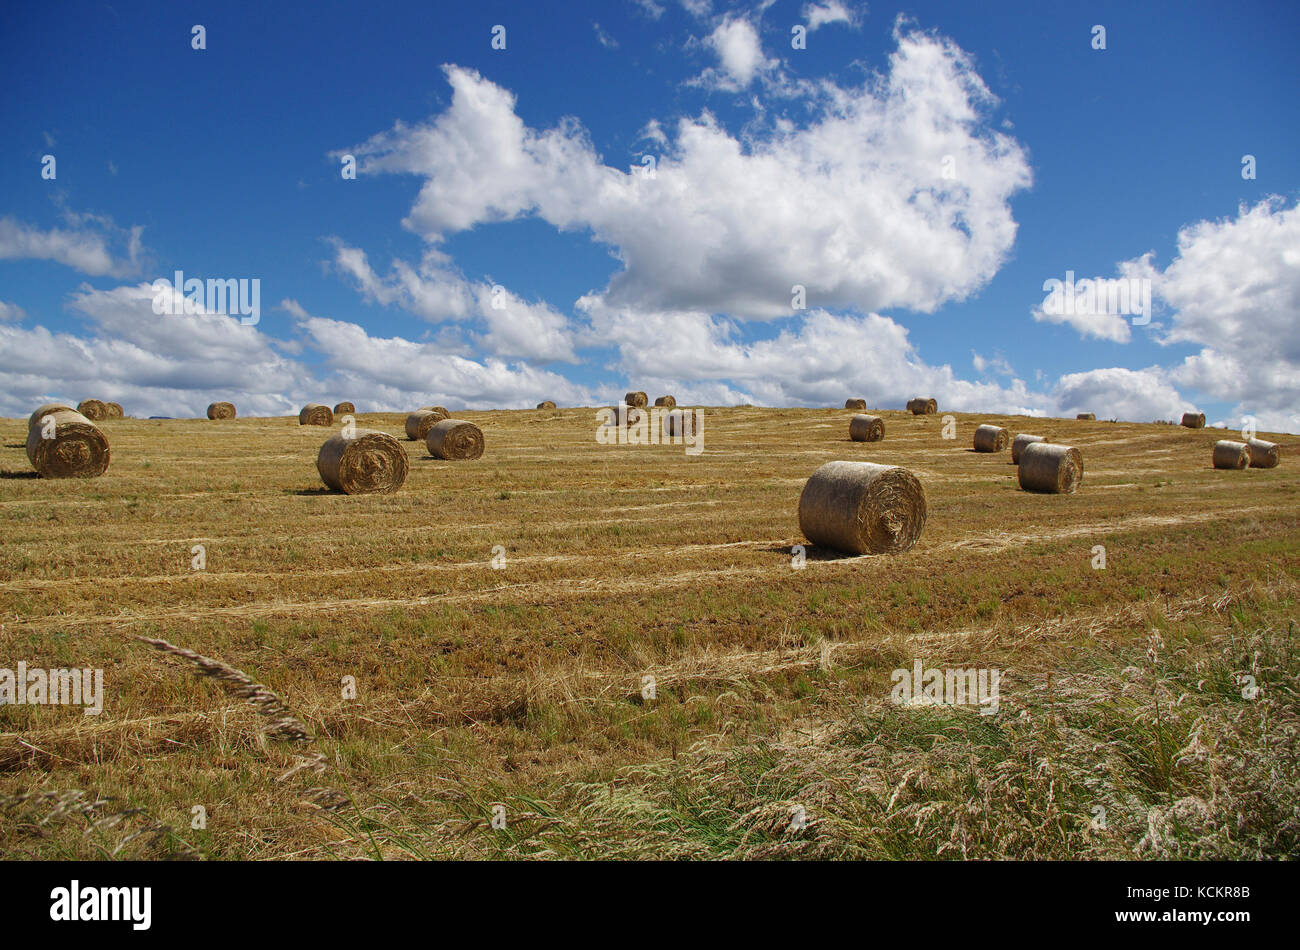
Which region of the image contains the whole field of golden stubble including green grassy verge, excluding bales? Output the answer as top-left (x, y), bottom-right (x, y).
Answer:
top-left (0, 408), bottom-right (1300, 859)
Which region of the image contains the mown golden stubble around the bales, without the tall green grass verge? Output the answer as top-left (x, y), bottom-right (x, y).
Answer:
top-left (0, 408), bottom-right (1300, 858)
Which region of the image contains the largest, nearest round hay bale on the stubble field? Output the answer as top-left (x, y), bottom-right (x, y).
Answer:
top-left (800, 461), bottom-right (926, 554)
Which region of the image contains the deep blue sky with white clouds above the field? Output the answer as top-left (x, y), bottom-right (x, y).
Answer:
top-left (0, 0), bottom-right (1300, 431)
